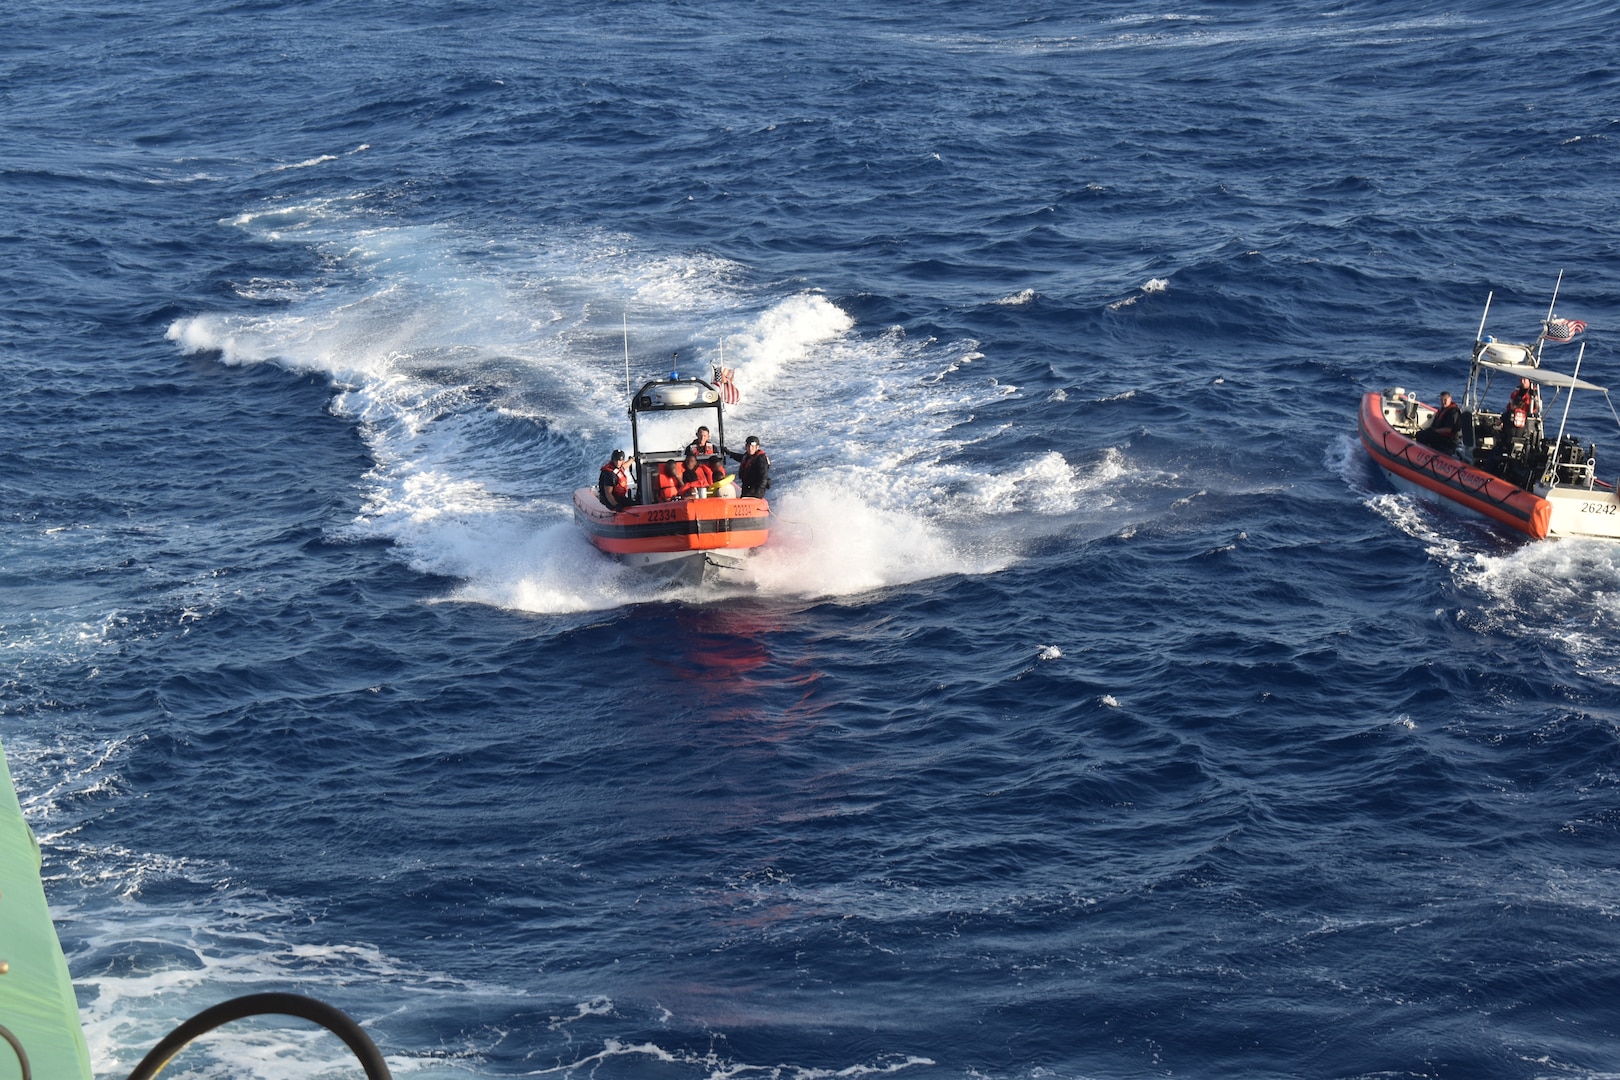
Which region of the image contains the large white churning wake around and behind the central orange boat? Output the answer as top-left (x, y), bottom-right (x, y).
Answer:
top-left (168, 204), bottom-right (1124, 614)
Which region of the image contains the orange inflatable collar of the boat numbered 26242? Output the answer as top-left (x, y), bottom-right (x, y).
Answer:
top-left (1361, 393), bottom-right (1552, 539)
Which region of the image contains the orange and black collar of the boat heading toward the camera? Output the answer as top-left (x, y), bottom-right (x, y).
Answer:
top-left (573, 487), bottom-right (771, 560)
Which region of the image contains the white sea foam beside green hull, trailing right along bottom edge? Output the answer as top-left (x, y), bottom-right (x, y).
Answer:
top-left (6, 729), bottom-right (932, 1080)
